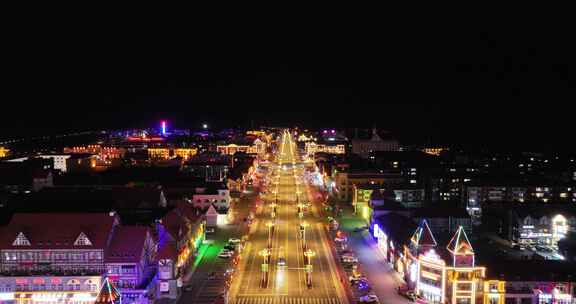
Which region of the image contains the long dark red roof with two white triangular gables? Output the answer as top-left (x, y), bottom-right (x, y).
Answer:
top-left (0, 213), bottom-right (118, 249)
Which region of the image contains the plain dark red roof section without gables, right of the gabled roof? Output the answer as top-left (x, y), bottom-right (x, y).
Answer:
top-left (106, 226), bottom-right (148, 263)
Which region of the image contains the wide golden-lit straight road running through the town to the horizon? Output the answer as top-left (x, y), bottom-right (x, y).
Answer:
top-left (230, 132), bottom-right (347, 304)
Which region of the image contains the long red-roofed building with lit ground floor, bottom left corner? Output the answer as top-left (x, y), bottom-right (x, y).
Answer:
top-left (0, 213), bottom-right (155, 304)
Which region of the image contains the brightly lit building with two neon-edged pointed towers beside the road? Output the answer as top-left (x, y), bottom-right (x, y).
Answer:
top-left (373, 220), bottom-right (486, 304)
